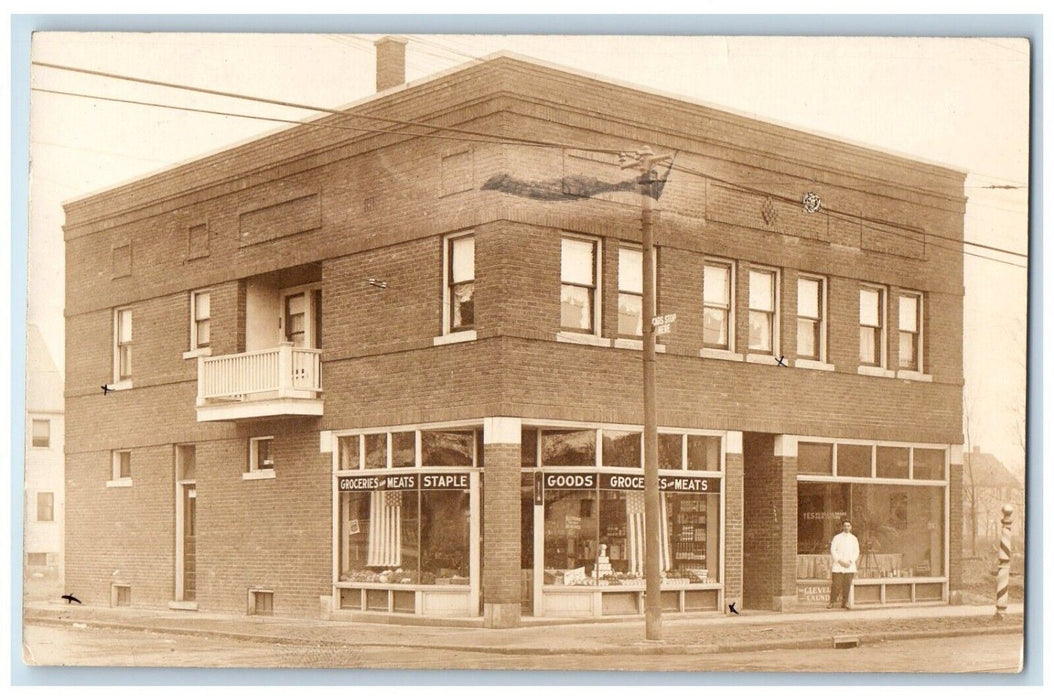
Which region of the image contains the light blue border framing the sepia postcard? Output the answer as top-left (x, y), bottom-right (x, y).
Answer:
top-left (9, 15), bottom-right (1043, 686)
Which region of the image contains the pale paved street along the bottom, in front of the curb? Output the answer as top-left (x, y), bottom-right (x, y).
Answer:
top-left (18, 624), bottom-right (1021, 673)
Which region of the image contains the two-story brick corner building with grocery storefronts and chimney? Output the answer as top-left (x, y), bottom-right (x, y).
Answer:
top-left (65, 40), bottom-right (965, 626)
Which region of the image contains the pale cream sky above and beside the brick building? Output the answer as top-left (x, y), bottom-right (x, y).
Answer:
top-left (28, 33), bottom-right (1030, 473)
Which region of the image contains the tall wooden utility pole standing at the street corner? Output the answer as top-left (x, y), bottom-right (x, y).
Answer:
top-left (619, 147), bottom-right (672, 641)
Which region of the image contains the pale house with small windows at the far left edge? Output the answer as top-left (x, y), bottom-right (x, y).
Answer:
top-left (22, 325), bottom-right (65, 600)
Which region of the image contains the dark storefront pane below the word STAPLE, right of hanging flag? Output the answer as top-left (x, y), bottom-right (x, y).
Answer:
top-left (421, 487), bottom-right (471, 585)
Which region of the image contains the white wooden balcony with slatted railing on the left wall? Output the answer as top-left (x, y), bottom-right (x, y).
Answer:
top-left (197, 343), bottom-right (323, 422)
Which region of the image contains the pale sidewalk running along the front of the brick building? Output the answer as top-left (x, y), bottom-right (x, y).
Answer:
top-left (24, 603), bottom-right (1023, 656)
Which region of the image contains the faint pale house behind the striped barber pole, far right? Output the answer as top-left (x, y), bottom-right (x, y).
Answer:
top-left (962, 446), bottom-right (1024, 551)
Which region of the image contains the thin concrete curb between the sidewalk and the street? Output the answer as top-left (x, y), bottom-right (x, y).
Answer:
top-left (25, 616), bottom-right (1023, 656)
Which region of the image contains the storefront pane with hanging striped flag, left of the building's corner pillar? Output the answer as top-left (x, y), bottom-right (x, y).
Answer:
top-left (339, 489), bottom-right (419, 584)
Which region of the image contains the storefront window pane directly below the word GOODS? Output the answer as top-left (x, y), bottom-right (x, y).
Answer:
top-left (545, 484), bottom-right (599, 585)
